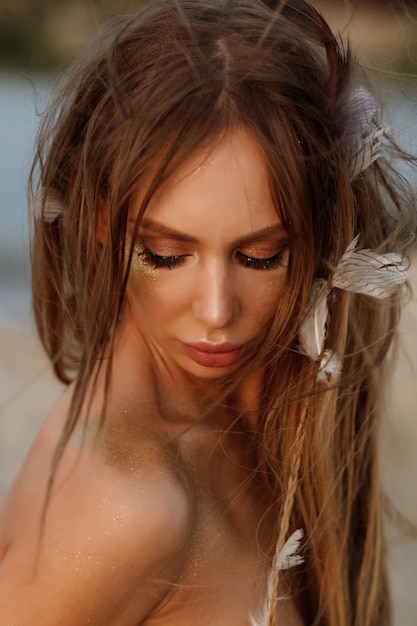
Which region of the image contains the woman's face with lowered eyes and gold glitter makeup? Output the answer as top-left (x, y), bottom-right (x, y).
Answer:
top-left (124, 129), bottom-right (288, 379)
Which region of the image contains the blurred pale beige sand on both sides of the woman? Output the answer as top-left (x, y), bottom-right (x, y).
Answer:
top-left (0, 263), bottom-right (417, 626)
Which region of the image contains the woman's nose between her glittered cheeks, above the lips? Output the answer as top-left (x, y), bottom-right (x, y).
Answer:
top-left (193, 261), bottom-right (240, 330)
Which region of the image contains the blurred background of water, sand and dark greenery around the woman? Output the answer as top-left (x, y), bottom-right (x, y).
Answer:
top-left (0, 0), bottom-right (417, 626)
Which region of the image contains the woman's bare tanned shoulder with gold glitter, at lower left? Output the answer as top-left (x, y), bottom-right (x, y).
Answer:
top-left (0, 390), bottom-right (193, 626)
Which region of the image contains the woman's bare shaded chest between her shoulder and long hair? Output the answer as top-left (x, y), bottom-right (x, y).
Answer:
top-left (144, 434), bottom-right (299, 626)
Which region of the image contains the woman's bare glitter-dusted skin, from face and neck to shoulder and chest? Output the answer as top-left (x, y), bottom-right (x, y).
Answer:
top-left (0, 129), bottom-right (301, 626)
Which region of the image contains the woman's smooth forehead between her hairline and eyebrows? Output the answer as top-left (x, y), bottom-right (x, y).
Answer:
top-left (132, 128), bottom-right (280, 238)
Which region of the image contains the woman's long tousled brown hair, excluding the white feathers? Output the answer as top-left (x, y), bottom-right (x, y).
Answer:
top-left (28, 0), bottom-right (407, 626)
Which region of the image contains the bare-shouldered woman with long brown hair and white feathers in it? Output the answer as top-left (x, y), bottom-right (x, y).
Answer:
top-left (0, 0), bottom-right (409, 626)
